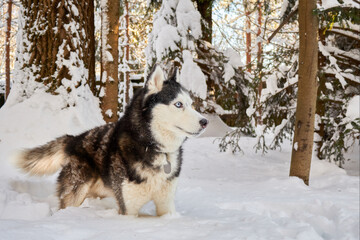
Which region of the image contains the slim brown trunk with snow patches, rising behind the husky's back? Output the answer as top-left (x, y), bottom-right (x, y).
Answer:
top-left (100, 0), bottom-right (120, 122)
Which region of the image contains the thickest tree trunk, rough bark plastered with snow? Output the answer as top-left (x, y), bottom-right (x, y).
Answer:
top-left (18, 0), bottom-right (95, 100)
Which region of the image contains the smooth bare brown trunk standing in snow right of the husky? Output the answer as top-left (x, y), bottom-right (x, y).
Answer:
top-left (290, 0), bottom-right (318, 185)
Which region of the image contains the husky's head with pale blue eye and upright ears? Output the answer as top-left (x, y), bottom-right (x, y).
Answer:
top-left (145, 66), bottom-right (208, 151)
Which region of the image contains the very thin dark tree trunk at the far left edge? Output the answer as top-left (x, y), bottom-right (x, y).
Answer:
top-left (5, 0), bottom-right (13, 100)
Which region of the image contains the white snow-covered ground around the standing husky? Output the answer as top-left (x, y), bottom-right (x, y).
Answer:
top-left (0, 91), bottom-right (359, 240)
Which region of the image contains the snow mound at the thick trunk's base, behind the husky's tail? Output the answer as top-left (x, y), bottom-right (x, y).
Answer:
top-left (0, 89), bottom-right (104, 177)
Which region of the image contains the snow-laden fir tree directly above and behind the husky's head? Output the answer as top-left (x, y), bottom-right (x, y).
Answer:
top-left (146, 0), bottom-right (207, 95)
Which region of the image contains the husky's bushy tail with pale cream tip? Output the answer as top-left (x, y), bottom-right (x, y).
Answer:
top-left (15, 136), bottom-right (69, 176)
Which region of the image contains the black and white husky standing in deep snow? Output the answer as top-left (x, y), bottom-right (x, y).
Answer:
top-left (17, 66), bottom-right (208, 216)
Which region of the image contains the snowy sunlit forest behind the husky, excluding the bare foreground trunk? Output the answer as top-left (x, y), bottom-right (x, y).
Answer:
top-left (0, 0), bottom-right (360, 171)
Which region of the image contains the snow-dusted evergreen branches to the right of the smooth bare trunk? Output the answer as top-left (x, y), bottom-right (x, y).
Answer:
top-left (315, 1), bottom-right (360, 167)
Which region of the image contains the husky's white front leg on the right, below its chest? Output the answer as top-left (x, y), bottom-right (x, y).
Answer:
top-left (153, 178), bottom-right (177, 216)
